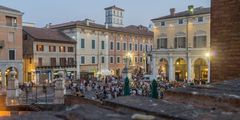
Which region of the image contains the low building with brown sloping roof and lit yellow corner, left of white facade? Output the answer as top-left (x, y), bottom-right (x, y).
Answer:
top-left (23, 27), bottom-right (76, 84)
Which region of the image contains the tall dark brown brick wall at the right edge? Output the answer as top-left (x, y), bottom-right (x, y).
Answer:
top-left (211, 0), bottom-right (240, 82)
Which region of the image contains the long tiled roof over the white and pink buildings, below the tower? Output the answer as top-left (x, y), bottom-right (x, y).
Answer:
top-left (50, 21), bottom-right (153, 36)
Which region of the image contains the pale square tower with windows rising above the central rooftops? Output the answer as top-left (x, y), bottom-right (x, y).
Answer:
top-left (105, 5), bottom-right (124, 27)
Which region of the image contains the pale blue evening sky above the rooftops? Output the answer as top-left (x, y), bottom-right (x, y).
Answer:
top-left (0, 0), bottom-right (211, 27)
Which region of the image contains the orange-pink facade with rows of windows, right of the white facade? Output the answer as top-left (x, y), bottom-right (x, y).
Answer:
top-left (109, 25), bottom-right (153, 76)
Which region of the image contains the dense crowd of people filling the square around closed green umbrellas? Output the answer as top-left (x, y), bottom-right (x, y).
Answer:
top-left (66, 77), bottom-right (191, 100)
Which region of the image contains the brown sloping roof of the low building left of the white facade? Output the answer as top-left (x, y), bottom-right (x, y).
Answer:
top-left (23, 26), bottom-right (76, 43)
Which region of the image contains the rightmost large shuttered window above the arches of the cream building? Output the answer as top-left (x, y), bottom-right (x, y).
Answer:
top-left (193, 36), bottom-right (207, 48)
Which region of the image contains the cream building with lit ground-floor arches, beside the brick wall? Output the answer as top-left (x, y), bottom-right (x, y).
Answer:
top-left (152, 6), bottom-right (210, 83)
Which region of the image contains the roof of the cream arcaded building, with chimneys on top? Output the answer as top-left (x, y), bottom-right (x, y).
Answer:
top-left (152, 7), bottom-right (211, 21)
